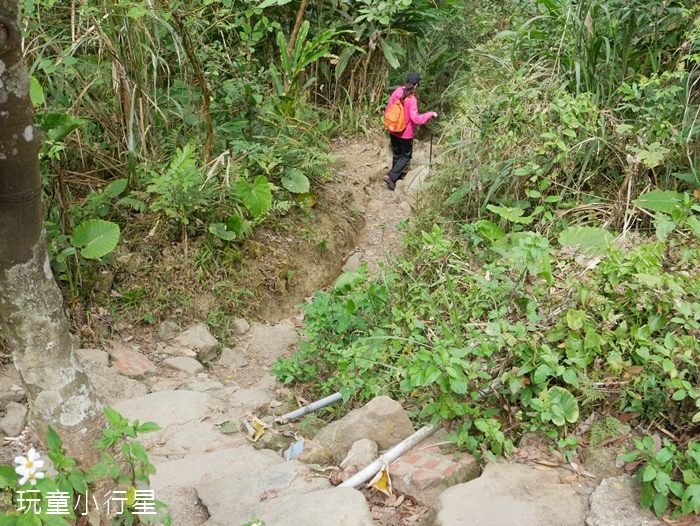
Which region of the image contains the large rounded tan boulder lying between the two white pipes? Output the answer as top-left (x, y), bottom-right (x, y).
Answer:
top-left (315, 396), bottom-right (414, 462)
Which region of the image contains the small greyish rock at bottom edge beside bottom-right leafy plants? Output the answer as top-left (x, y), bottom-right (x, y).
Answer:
top-left (586, 475), bottom-right (665, 526)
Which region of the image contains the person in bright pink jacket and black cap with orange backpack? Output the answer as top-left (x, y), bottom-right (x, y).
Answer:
top-left (384, 72), bottom-right (437, 190)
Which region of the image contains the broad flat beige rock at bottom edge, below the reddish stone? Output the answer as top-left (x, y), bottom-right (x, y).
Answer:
top-left (428, 462), bottom-right (588, 526)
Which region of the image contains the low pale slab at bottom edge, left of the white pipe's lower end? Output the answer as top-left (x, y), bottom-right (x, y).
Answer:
top-left (204, 488), bottom-right (374, 526)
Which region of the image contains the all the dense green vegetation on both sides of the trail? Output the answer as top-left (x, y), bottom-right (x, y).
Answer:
top-left (4, 0), bottom-right (700, 515)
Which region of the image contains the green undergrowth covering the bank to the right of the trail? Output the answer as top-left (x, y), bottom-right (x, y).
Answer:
top-left (274, 1), bottom-right (700, 518)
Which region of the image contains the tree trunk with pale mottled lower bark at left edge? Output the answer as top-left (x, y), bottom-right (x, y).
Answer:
top-left (0, 0), bottom-right (104, 465)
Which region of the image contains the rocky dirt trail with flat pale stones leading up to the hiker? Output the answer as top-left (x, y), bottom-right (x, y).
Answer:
top-left (0, 135), bottom-right (661, 526)
